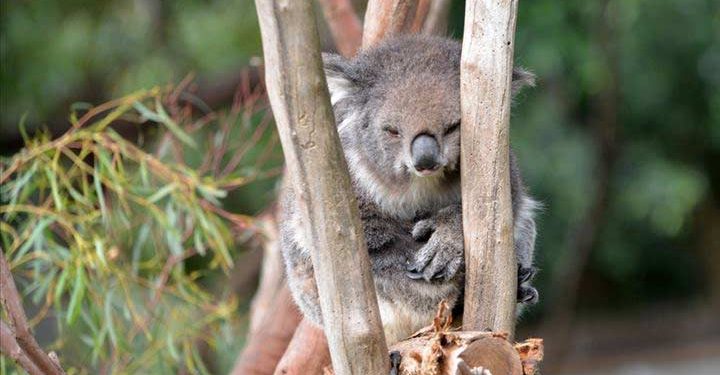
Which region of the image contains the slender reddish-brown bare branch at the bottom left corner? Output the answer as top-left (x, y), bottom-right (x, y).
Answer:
top-left (0, 249), bottom-right (65, 375)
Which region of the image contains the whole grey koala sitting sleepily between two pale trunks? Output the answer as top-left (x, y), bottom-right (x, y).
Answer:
top-left (280, 36), bottom-right (538, 343)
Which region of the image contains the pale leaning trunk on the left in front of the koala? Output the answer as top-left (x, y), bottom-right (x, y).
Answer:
top-left (255, 0), bottom-right (389, 374)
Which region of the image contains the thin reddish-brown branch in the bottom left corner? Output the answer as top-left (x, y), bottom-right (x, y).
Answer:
top-left (0, 249), bottom-right (65, 375)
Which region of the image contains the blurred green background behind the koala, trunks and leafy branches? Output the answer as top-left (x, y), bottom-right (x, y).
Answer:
top-left (0, 0), bottom-right (720, 373)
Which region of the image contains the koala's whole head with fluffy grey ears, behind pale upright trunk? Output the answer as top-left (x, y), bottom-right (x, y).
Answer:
top-left (323, 36), bottom-right (532, 216)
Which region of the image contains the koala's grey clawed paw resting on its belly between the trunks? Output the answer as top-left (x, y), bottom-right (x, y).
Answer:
top-left (407, 219), bottom-right (465, 281)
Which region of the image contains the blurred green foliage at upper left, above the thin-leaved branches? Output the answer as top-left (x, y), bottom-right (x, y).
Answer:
top-left (0, 0), bottom-right (260, 135)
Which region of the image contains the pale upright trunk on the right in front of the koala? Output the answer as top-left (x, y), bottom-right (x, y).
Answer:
top-left (460, 0), bottom-right (518, 336)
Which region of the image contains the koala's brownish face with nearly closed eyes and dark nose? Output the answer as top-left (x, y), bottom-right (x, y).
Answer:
top-left (362, 72), bottom-right (460, 182)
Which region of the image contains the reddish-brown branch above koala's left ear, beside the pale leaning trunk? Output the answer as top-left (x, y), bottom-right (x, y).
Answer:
top-left (318, 0), bottom-right (362, 57)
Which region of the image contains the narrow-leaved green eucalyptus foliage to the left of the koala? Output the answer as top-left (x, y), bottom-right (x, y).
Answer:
top-left (0, 83), bottom-right (277, 373)
